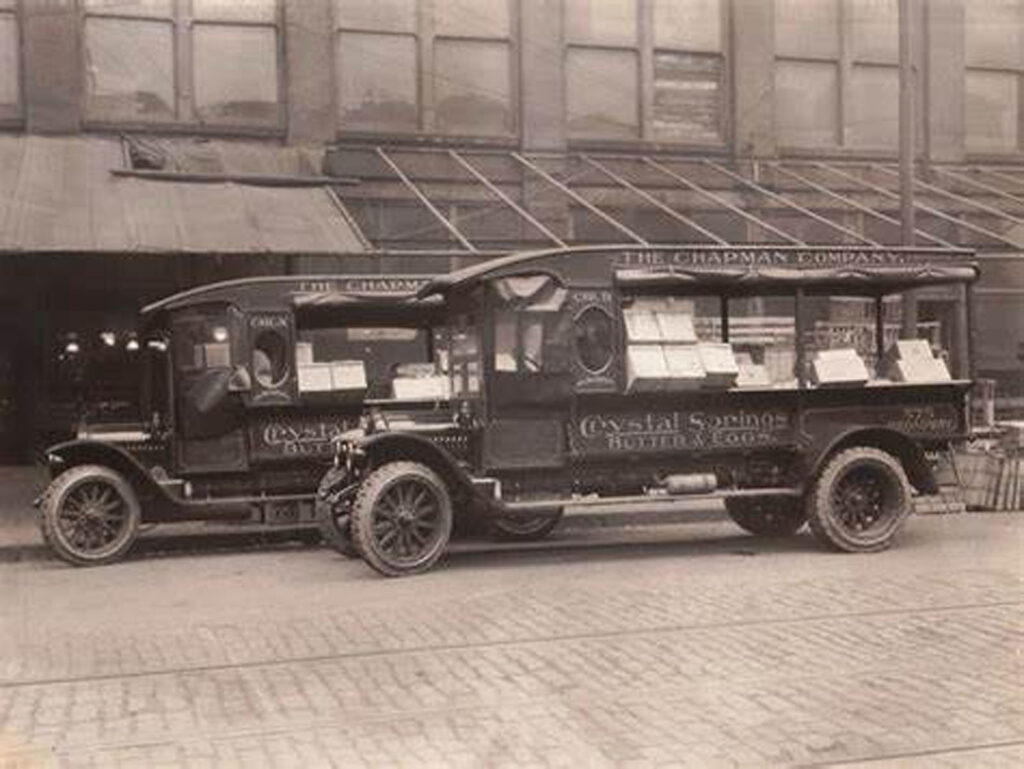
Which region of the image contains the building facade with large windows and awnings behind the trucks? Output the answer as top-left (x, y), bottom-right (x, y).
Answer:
top-left (0, 0), bottom-right (1024, 458)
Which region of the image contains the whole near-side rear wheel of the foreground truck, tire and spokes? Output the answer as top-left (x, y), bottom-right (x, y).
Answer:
top-left (807, 446), bottom-right (913, 553)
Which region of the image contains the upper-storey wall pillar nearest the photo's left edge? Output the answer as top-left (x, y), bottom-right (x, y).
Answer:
top-left (20, 0), bottom-right (85, 133)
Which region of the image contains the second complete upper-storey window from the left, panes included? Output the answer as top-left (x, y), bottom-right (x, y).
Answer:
top-left (334, 0), bottom-right (516, 136)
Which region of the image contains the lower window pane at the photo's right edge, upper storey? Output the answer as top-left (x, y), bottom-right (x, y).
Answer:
top-left (965, 71), bottom-right (1020, 152)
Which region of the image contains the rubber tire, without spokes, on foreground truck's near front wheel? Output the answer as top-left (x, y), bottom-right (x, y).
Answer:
top-left (351, 462), bottom-right (453, 576)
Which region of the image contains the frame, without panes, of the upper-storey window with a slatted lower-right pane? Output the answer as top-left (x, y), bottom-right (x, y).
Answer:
top-left (562, 0), bottom-right (734, 152)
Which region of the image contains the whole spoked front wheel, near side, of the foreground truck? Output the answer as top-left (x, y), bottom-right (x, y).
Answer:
top-left (351, 462), bottom-right (452, 576)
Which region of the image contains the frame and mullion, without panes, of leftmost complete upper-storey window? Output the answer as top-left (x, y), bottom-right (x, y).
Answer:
top-left (78, 0), bottom-right (288, 138)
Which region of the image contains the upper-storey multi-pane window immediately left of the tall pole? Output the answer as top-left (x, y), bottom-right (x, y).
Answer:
top-left (774, 0), bottom-right (899, 149)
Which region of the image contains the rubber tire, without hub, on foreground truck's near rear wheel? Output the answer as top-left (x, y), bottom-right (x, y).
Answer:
top-left (807, 446), bottom-right (913, 553)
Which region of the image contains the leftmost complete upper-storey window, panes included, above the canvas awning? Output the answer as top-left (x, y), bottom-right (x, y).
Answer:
top-left (83, 0), bottom-right (282, 128)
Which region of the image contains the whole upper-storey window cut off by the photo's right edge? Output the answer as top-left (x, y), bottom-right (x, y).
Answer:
top-left (964, 0), bottom-right (1024, 153)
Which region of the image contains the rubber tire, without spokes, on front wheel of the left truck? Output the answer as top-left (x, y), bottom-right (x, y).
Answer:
top-left (40, 465), bottom-right (142, 566)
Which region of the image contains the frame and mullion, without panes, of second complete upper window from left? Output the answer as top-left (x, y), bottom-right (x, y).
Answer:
top-left (331, 0), bottom-right (522, 141)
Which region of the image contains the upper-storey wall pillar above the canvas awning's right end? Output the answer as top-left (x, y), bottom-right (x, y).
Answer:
top-left (283, 0), bottom-right (336, 144)
